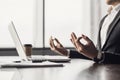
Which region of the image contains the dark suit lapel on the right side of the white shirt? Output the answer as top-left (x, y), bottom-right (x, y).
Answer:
top-left (103, 11), bottom-right (120, 49)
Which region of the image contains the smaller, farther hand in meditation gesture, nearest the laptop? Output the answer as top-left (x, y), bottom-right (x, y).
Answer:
top-left (49, 36), bottom-right (68, 56)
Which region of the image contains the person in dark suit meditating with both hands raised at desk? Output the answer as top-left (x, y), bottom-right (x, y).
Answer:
top-left (50, 0), bottom-right (120, 64)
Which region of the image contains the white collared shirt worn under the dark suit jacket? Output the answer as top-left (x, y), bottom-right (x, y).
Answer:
top-left (100, 4), bottom-right (120, 47)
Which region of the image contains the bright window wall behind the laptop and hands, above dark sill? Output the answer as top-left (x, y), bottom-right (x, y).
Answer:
top-left (0, 0), bottom-right (108, 48)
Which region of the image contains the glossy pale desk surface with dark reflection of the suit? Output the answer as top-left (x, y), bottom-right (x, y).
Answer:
top-left (0, 56), bottom-right (120, 80)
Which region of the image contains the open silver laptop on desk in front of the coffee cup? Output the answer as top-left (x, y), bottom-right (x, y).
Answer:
top-left (8, 21), bottom-right (70, 62)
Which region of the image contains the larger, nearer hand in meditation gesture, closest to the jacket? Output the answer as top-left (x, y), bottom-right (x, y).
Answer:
top-left (71, 33), bottom-right (98, 59)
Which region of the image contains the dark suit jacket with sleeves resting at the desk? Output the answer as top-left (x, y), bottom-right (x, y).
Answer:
top-left (70, 11), bottom-right (120, 64)
